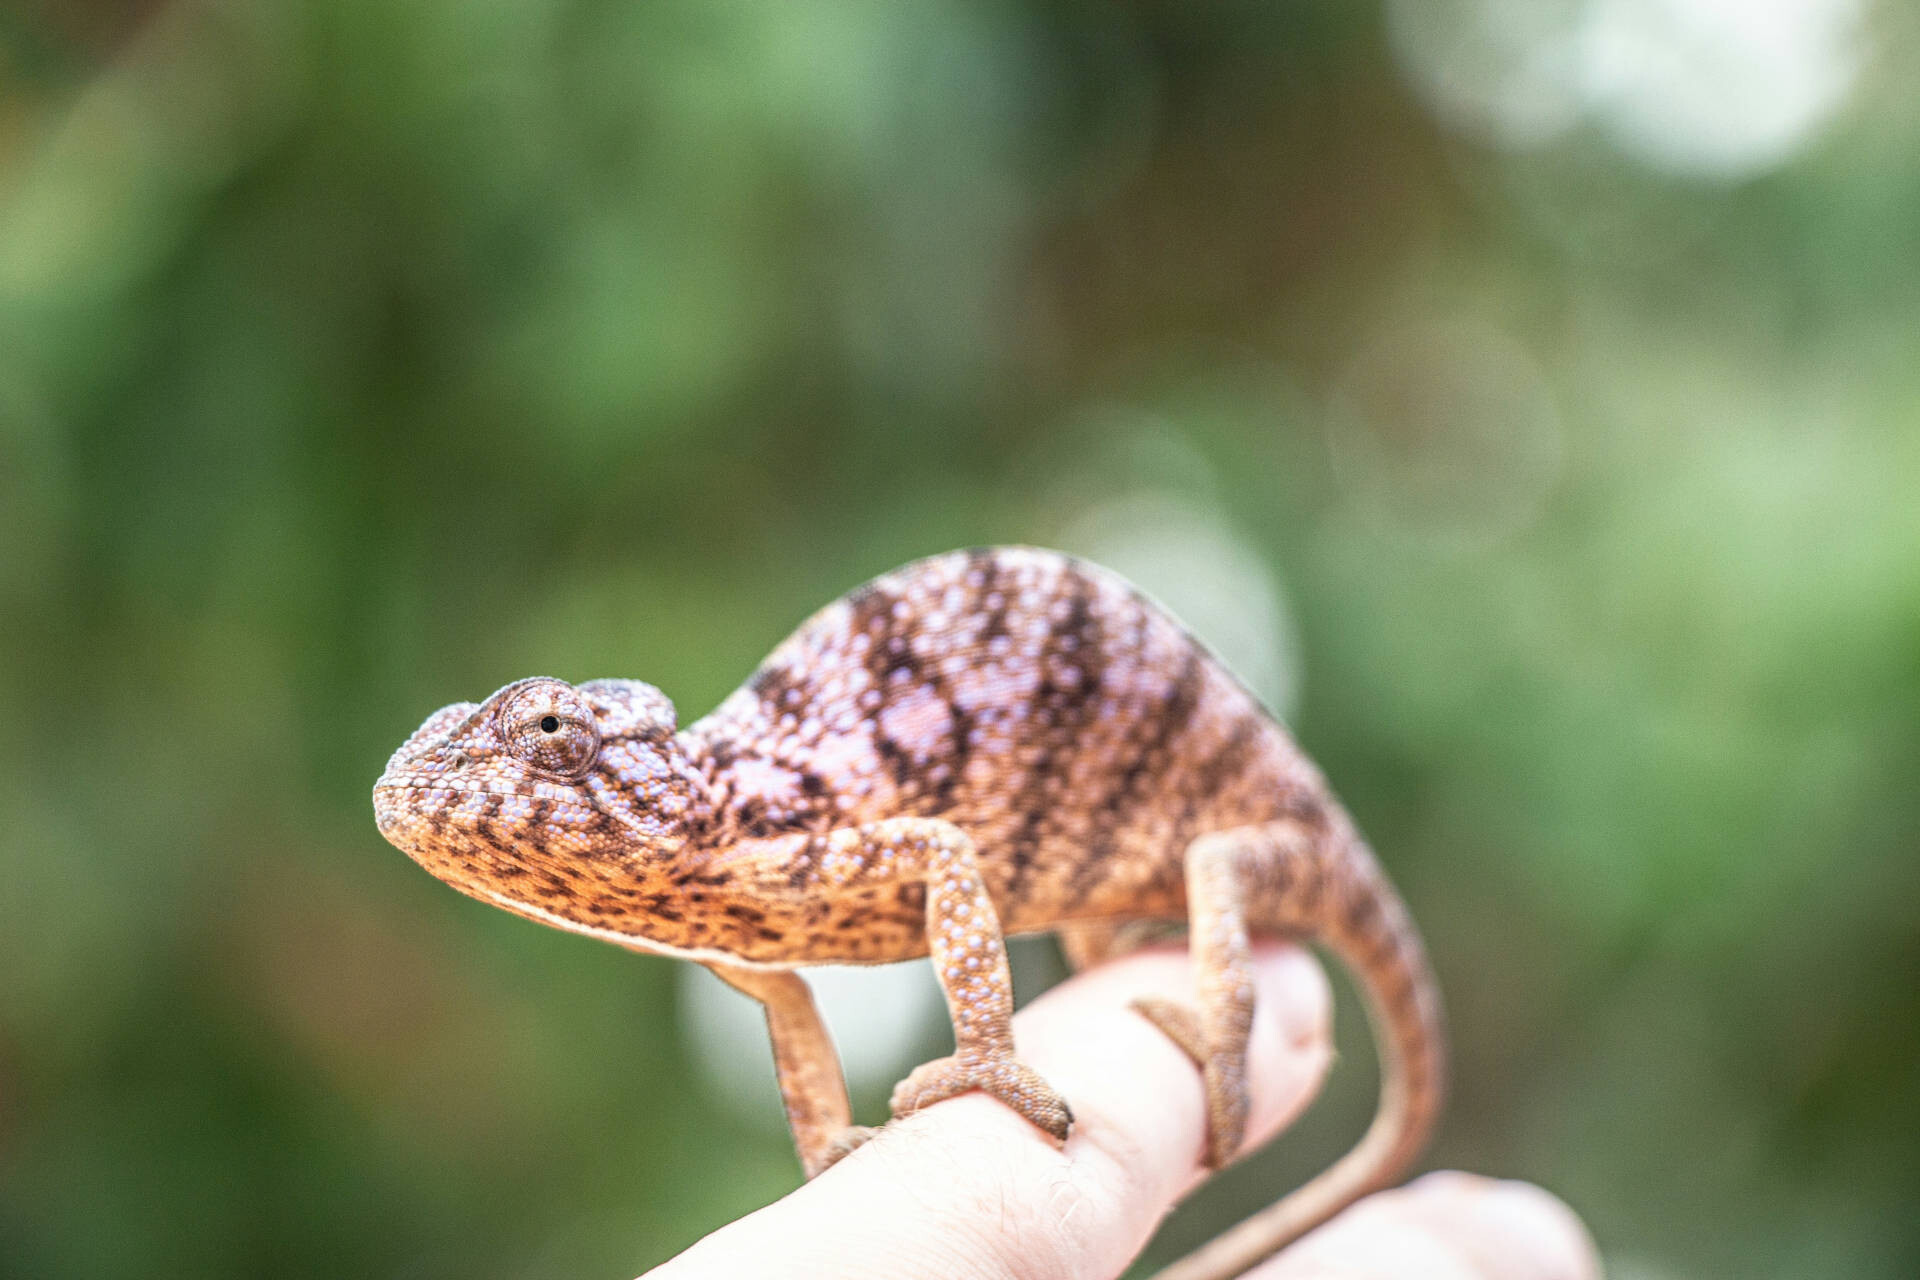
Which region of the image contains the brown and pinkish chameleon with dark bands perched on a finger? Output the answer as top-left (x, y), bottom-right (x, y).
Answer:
top-left (372, 547), bottom-right (1446, 1280)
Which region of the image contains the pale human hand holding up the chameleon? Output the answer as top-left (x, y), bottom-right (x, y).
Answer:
top-left (647, 944), bottom-right (1599, 1280)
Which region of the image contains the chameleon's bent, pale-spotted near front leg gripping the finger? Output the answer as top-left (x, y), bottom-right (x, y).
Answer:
top-left (824, 818), bottom-right (1073, 1142)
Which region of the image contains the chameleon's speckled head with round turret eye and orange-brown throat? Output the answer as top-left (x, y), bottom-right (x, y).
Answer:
top-left (372, 677), bottom-right (705, 935)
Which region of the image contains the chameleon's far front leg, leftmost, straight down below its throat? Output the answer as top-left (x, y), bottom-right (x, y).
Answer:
top-left (707, 963), bottom-right (874, 1178)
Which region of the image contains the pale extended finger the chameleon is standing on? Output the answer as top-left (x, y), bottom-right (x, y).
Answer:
top-left (651, 944), bottom-right (1331, 1280)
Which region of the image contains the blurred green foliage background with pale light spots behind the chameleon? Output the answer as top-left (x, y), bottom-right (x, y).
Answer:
top-left (0, 0), bottom-right (1920, 1280)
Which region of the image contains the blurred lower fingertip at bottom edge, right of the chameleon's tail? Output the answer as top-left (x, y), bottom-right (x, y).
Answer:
top-left (1246, 1173), bottom-right (1599, 1280)
